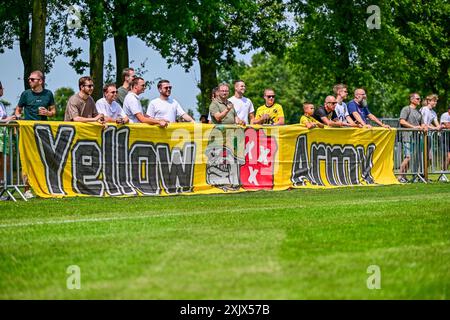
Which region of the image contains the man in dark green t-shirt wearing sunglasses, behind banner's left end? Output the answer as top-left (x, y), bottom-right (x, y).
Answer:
top-left (15, 70), bottom-right (56, 121)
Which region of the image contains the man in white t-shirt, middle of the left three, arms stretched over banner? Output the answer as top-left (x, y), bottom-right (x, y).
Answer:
top-left (123, 77), bottom-right (169, 128)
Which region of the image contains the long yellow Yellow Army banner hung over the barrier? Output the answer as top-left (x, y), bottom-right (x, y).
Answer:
top-left (18, 121), bottom-right (398, 197)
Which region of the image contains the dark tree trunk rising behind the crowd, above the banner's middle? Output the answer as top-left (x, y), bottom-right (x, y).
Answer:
top-left (196, 36), bottom-right (217, 114)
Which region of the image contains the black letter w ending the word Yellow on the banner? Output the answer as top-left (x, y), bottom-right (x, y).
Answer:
top-left (156, 142), bottom-right (195, 194)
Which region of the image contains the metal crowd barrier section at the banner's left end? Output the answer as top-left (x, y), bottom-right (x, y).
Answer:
top-left (0, 123), bottom-right (27, 201)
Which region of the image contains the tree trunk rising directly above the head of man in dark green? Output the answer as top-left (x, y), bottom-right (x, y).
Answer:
top-left (31, 0), bottom-right (47, 73)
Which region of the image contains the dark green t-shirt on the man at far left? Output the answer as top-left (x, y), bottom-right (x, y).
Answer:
top-left (17, 89), bottom-right (55, 120)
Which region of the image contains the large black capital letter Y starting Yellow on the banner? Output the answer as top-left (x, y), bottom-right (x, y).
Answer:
top-left (34, 124), bottom-right (75, 195)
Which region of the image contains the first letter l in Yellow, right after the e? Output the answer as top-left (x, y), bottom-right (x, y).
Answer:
top-left (102, 126), bottom-right (121, 196)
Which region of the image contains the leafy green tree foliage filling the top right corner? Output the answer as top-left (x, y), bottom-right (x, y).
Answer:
top-left (388, 0), bottom-right (450, 111)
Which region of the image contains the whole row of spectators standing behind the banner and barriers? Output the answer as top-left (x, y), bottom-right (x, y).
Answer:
top-left (0, 68), bottom-right (450, 198)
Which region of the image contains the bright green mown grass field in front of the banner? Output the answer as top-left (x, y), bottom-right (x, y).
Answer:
top-left (0, 183), bottom-right (450, 299)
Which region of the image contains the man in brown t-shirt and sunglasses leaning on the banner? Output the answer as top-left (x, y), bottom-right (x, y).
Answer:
top-left (64, 77), bottom-right (105, 124)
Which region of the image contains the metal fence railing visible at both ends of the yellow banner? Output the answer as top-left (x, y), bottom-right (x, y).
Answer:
top-left (0, 122), bottom-right (450, 201)
